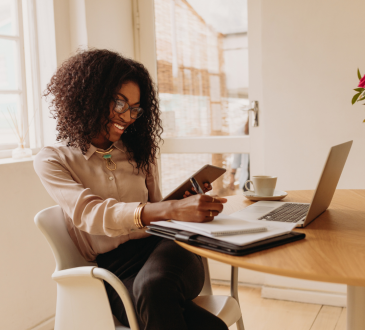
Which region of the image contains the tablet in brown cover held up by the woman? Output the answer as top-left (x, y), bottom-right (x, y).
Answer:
top-left (161, 164), bottom-right (226, 202)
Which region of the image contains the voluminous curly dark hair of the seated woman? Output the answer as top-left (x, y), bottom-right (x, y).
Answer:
top-left (43, 49), bottom-right (163, 174)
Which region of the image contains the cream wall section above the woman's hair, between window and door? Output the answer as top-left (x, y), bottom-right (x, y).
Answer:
top-left (54, 0), bottom-right (134, 66)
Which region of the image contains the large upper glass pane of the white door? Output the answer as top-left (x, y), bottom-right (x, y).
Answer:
top-left (155, 0), bottom-right (248, 137)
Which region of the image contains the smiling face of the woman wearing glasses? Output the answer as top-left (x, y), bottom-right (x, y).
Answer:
top-left (91, 81), bottom-right (140, 149)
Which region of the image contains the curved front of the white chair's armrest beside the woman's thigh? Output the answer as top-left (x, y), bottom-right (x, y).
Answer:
top-left (92, 267), bottom-right (139, 330)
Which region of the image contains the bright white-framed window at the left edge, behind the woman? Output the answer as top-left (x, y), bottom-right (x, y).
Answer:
top-left (0, 0), bottom-right (40, 156)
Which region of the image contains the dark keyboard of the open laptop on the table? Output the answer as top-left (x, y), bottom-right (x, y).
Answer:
top-left (258, 203), bottom-right (310, 222)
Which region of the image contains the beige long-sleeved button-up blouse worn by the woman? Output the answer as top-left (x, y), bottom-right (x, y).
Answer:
top-left (34, 141), bottom-right (162, 261)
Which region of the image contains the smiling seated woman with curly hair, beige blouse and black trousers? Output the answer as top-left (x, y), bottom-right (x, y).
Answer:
top-left (34, 50), bottom-right (227, 330)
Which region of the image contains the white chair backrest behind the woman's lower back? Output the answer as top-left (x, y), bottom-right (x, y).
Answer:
top-left (34, 205), bottom-right (96, 271)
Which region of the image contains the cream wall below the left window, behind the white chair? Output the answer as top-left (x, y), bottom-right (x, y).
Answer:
top-left (0, 161), bottom-right (56, 330)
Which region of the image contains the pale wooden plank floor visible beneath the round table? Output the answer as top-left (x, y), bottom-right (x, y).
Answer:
top-left (213, 285), bottom-right (346, 330)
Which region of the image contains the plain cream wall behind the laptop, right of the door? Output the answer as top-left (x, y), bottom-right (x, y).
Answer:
top-left (248, 0), bottom-right (365, 190)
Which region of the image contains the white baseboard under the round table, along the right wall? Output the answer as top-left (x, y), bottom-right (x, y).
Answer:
top-left (261, 285), bottom-right (346, 307)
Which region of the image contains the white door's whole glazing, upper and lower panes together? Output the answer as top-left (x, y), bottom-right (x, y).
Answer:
top-left (154, 0), bottom-right (249, 195)
